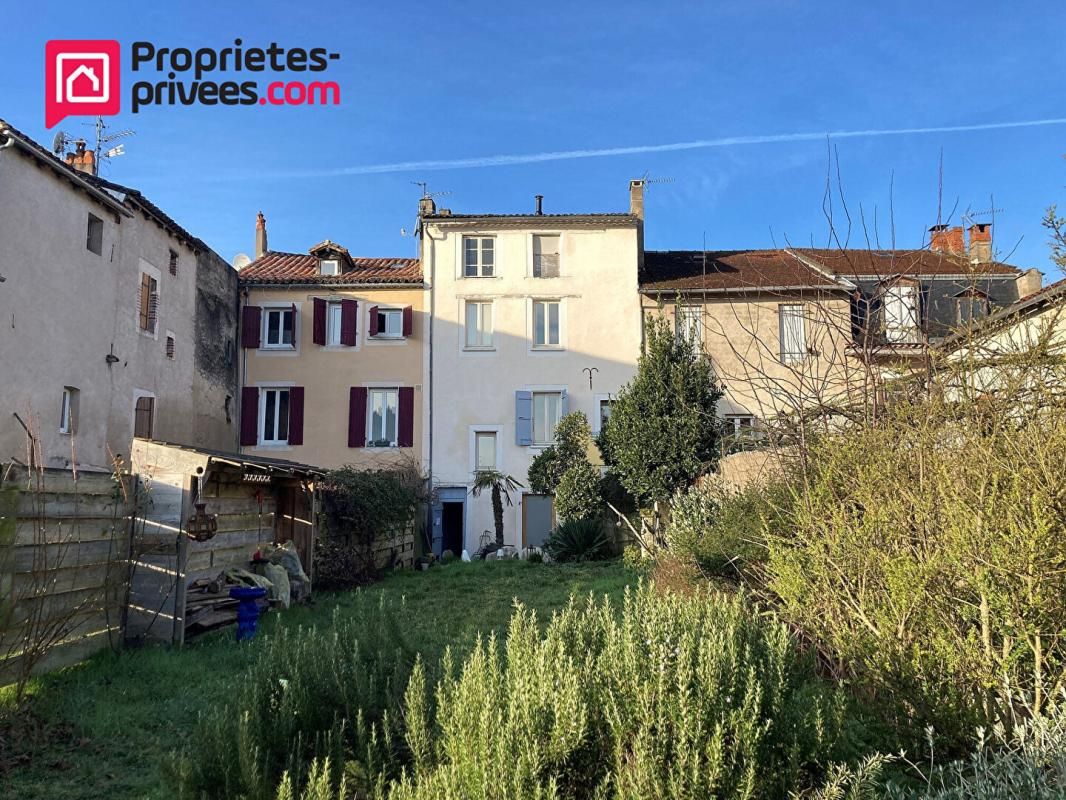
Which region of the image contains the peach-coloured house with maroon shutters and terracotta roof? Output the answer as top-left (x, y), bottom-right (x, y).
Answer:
top-left (240, 213), bottom-right (425, 468)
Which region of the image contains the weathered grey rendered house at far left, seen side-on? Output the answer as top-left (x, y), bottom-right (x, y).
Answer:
top-left (0, 122), bottom-right (238, 470)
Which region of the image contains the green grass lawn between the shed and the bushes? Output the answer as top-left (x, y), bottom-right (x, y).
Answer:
top-left (0, 561), bottom-right (636, 800)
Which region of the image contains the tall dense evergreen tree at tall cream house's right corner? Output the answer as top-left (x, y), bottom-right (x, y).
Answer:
top-left (599, 318), bottom-right (722, 506)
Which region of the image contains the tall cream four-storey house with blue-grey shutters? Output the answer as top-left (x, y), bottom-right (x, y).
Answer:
top-left (419, 180), bottom-right (644, 554)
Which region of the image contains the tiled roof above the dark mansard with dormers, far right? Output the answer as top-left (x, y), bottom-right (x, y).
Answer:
top-left (793, 247), bottom-right (1021, 277)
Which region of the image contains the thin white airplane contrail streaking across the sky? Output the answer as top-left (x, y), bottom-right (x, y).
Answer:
top-left (244, 117), bottom-right (1066, 178)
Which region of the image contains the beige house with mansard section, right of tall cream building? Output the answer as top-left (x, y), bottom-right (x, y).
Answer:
top-left (641, 224), bottom-right (1041, 443)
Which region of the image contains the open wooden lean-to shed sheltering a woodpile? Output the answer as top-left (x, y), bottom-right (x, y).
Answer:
top-left (126, 439), bottom-right (322, 644)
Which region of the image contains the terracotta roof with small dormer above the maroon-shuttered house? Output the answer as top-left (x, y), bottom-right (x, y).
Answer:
top-left (241, 251), bottom-right (422, 286)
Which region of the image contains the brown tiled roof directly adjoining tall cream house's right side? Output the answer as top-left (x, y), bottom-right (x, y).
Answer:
top-left (641, 250), bottom-right (850, 291)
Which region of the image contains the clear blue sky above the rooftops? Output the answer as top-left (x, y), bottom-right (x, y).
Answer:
top-left (0, 0), bottom-right (1066, 277)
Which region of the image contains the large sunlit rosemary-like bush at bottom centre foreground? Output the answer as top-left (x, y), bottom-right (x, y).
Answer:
top-left (282, 587), bottom-right (840, 800)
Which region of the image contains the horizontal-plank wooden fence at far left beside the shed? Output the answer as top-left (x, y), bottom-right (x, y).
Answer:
top-left (0, 465), bottom-right (131, 685)
